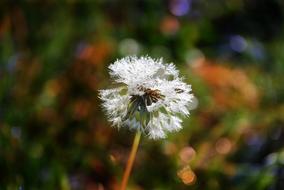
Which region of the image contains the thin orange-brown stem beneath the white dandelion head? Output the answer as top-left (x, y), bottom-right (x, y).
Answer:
top-left (120, 131), bottom-right (141, 190)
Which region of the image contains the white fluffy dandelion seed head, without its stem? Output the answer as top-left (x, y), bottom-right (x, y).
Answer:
top-left (99, 56), bottom-right (193, 139)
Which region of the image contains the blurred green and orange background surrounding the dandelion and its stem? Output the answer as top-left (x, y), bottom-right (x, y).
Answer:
top-left (0, 0), bottom-right (284, 190)
